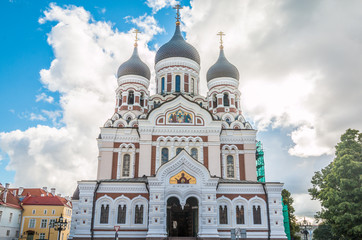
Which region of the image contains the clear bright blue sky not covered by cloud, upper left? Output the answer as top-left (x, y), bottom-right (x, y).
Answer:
top-left (0, 0), bottom-right (189, 183)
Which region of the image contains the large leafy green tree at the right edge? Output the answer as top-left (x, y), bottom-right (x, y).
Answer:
top-left (308, 129), bottom-right (362, 239)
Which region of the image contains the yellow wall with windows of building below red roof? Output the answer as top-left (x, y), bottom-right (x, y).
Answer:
top-left (19, 205), bottom-right (72, 240)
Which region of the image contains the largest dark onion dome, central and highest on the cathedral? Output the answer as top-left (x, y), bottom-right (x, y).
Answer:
top-left (155, 25), bottom-right (200, 64)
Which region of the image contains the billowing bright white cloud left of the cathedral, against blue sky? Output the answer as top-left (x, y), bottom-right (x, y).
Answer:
top-left (0, 4), bottom-right (159, 194)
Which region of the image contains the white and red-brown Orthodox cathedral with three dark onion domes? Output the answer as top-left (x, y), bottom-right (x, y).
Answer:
top-left (70, 6), bottom-right (286, 240)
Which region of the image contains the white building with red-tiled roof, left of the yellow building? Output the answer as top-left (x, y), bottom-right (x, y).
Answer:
top-left (0, 184), bottom-right (23, 240)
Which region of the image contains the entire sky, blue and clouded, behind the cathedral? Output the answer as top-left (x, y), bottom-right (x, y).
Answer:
top-left (0, 0), bottom-right (362, 219)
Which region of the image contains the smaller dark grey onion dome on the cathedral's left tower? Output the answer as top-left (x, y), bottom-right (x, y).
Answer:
top-left (117, 47), bottom-right (151, 80)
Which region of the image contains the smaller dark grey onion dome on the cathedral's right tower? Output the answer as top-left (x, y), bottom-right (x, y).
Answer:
top-left (206, 49), bottom-right (239, 81)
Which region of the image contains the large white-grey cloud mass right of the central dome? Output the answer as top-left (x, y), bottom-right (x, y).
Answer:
top-left (182, 0), bottom-right (362, 157)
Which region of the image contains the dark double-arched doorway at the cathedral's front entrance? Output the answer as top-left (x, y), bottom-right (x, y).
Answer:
top-left (167, 197), bottom-right (199, 237)
